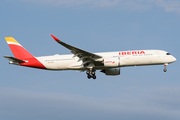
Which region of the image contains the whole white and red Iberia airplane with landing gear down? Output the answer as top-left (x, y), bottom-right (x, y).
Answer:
top-left (4, 34), bottom-right (176, 79)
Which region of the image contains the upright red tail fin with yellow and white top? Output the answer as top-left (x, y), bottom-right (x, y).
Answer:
top-left (5, 37), bottom-right (33, 60)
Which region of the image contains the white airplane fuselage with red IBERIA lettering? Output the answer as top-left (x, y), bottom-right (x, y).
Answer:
top-left (36, 50), bottom-right (176, 70)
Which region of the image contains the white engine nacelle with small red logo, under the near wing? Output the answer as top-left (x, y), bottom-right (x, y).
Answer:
top-left (104, 57), bottom-right (120, 67)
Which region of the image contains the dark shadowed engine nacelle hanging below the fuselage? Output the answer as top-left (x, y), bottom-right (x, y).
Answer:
top-left (101, 68), bottom-right (120, 76)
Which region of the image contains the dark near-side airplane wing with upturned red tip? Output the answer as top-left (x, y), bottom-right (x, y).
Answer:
top-left (50, 34), bottom-right (102, 64)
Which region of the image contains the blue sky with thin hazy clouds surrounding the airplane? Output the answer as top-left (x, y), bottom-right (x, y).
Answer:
top-left (0, 0), bottom-right (180, 120)
